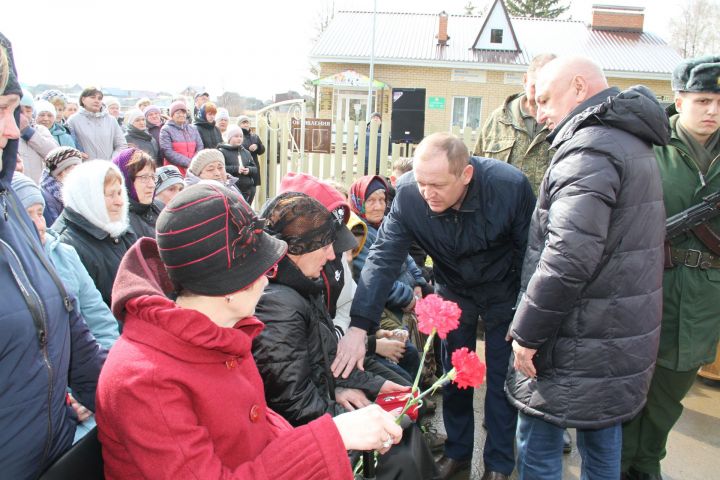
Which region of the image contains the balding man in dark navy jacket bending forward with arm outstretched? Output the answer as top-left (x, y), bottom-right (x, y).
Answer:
top-left (340, 133), bottom-right (535, 480)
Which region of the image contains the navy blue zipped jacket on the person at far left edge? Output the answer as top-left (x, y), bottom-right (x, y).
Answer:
top-left (0, 133), bottom-right (106, 479)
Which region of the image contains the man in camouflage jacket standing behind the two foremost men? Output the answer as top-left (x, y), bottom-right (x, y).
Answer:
top-left (473, 54), bottom-right (555, 195)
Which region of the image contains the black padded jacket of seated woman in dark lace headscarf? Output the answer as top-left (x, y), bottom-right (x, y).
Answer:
top-left (253, 257), bottom-right (385, 426)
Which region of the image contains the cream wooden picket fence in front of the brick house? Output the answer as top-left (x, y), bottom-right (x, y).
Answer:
top-left (255, 110), bottom-right (479, 208)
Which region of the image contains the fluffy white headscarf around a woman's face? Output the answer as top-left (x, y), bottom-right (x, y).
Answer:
top-left (62, 160), bottom-right (130, 237)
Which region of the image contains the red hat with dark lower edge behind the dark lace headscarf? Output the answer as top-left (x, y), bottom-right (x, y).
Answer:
top-left (278, 172), bottom-right (357, 252)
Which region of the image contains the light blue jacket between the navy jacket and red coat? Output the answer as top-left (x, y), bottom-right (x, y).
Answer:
top-left (45, 229), bottom-right (120, 350)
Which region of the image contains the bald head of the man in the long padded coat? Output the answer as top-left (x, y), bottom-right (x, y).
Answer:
top-left (535, 57), bottom-right (608, 130)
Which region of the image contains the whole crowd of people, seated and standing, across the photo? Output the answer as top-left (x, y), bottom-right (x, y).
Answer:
top-left (0, 25), bottom-right (720, 480)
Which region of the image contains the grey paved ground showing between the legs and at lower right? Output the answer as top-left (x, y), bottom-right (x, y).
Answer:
top-left (424, 342), bottom-right (720, 480)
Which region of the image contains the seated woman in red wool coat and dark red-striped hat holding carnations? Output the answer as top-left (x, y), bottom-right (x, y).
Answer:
top-left (96, 183), bottom-right (402, 480)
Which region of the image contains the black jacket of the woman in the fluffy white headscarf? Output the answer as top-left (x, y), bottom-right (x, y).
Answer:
top-left (52, 207), bottom-right (137, 307)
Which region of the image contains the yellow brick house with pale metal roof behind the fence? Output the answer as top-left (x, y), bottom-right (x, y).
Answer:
top-left (310, 0), bottom-right (681, 141)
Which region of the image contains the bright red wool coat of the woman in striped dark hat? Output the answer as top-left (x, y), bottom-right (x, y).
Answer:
top-left (96, 294), bottom-right (352, 480)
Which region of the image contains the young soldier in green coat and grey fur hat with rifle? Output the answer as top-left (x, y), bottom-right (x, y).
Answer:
top-left (622, 55), bottom-right (720, 480)
